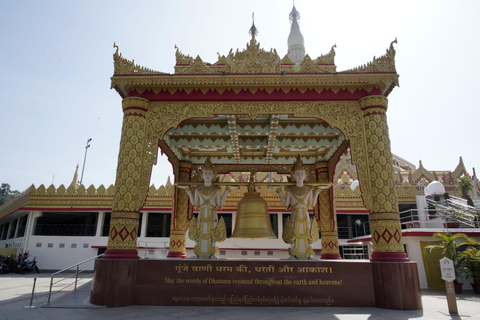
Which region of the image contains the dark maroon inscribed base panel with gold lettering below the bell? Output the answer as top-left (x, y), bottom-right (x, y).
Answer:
top-left (135, 259), bottom-right (375, 307)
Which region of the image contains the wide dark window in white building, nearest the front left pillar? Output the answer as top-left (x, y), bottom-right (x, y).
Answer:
top-left (34, 212), bottom-right (98, 236)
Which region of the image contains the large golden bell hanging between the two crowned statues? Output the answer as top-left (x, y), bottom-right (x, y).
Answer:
top-left (231, 192), bottom-right (277, 238)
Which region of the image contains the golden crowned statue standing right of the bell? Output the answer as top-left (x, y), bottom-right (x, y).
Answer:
top-left (277, 155), bottom-right (319, 259)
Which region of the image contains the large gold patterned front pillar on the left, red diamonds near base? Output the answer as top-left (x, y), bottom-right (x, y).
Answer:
top-left (103, 98), bottom-right (158, 259)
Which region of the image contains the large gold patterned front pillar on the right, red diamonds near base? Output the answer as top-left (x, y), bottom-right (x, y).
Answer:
top-left (359, 96), bottom-right (409, 262)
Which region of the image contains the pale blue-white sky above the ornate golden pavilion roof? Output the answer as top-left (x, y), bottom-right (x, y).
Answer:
top-left (0, 0), bottom-right (480, 191)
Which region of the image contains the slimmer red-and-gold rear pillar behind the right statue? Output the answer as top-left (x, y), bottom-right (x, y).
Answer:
top-left (315, 162), bottom-right (341, 259)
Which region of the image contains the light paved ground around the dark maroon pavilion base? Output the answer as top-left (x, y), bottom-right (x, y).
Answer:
top-left (0, 273), bottom-right (480, 320)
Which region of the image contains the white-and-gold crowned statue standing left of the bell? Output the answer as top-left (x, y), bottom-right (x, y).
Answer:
top-left (180, 157), bottom-right (234, 259)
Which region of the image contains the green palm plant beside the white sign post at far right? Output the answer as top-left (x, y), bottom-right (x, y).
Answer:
top-left (424, 232), bottom-right (468, 293)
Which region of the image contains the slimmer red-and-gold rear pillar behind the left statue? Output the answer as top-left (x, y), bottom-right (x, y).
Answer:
top-left (167, 161), bottom-right (193, 258)
